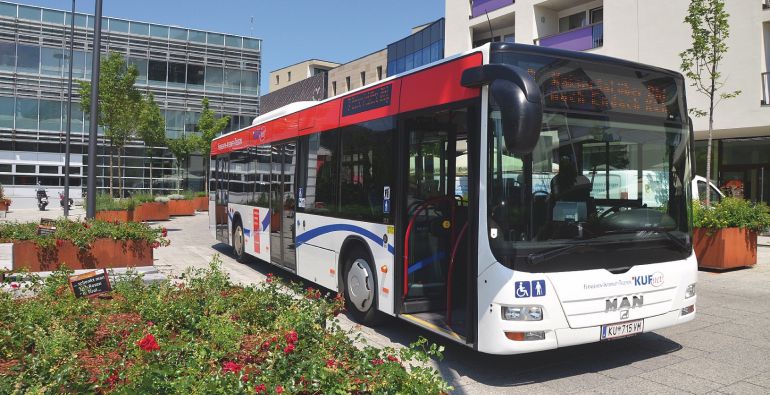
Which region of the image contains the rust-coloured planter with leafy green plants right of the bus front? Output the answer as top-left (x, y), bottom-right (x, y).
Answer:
top-left (693, 197), bottom-right (770, 270)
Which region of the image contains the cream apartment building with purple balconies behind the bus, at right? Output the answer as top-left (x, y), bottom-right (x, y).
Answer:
top-left (445, 0), bottom-right (770, 207)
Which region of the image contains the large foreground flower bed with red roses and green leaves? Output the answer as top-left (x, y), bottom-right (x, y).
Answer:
top-left (0, 262), bottom-right (451, 394)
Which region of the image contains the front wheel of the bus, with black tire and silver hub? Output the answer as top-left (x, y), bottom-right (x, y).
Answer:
top-left (342, 247), bottom-right (384, 326)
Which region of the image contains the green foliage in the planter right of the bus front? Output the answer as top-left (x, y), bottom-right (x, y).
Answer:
top-left (693, 197), bottom-right (770, 232)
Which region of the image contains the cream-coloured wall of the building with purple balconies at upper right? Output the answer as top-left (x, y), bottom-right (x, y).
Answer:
top-left (445, 0), bottom-right (770, 139)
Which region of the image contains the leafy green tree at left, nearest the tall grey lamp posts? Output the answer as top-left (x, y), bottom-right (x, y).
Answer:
top-left (79, 52), bottom-right (142, 197)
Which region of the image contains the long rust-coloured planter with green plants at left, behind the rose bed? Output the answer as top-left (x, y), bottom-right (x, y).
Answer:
top-left (0, 220), bottom-right (169, 271)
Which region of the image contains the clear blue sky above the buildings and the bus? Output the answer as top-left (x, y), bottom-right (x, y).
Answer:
top-left (18, 0), bottom-right (444, 94)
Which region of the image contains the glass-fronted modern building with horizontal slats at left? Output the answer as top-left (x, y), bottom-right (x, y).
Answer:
top-left (0, 2), bottom-right (261, 208)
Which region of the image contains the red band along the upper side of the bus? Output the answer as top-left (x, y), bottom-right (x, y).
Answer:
top-left (211, 52), bottom-right (482, 155)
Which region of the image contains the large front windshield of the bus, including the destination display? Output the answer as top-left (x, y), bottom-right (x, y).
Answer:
top-left (487, 49), bottom-right (692, 272)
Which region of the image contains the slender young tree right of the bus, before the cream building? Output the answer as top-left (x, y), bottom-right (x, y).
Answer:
top-left (679, 0), bottom-right (741, 205)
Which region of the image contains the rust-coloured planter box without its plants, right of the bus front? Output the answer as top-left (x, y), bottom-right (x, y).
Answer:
top-left (693, 228), bottom-right (757, 270)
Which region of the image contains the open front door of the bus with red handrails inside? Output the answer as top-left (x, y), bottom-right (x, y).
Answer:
top-left (401, 110), bottom-right (469, 337)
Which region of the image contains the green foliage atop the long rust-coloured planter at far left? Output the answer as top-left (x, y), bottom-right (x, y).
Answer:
top-left (0, 218), bottom-right (169, 249)
